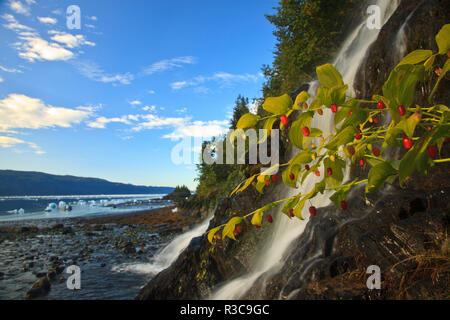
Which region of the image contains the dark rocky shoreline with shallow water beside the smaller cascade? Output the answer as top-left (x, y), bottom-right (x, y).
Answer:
top-left (0, 206), bottom-right (198, 299)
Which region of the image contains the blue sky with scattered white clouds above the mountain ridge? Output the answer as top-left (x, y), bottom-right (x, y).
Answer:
top-left (0, 0), bottom-right (277, 189)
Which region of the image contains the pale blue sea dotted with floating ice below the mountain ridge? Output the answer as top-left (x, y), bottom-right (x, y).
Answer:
top-left (0, 194), bottom-right (167, 221)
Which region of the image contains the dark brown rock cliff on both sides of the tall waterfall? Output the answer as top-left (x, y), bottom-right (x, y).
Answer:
top-left (137, 0), bottom-right (450, 299)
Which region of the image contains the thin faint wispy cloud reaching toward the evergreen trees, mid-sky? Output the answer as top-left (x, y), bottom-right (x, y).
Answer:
top-left (170, 72), bottom-right (261, 93)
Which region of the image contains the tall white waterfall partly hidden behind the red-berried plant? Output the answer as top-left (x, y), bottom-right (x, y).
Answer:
top-left (210, 0), bottom-right (399, 299)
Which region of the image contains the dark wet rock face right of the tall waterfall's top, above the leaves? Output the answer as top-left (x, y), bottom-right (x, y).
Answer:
top-left (354, 0), bottom-right (450, 104)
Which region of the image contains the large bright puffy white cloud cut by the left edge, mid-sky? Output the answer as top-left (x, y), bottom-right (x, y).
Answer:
top-left (0, 93), bottom-right (91, 130)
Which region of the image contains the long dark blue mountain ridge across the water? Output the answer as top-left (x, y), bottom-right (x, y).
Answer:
top-left (0, 170), bottom-right (174, 196)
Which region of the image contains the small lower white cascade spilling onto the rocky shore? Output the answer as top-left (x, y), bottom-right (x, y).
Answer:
top-left (112, 215), bottom-right (213, 275)
